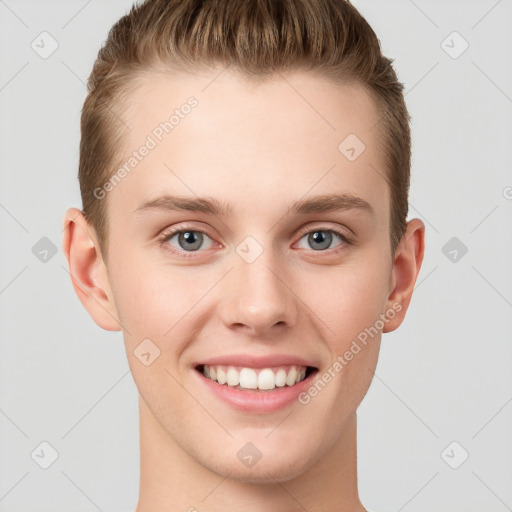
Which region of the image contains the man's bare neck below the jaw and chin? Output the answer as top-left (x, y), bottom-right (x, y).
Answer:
top-left (132, 396), bottom-right (365, 512)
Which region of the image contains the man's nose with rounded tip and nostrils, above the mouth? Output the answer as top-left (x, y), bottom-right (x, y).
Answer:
top-left (220, 250), bottom-right (298, 337)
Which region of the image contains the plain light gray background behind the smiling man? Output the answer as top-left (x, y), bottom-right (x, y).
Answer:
top-left (0, 0), bottom-right (512, 512)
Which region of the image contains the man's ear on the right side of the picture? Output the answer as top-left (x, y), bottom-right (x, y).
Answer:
top-left (382, 219), bottom-right (425, 332)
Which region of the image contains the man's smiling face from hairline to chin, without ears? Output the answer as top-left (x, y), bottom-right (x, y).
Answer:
top-left (72, 70), bottom-right (416, 482)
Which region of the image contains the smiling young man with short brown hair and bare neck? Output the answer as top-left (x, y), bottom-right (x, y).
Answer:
top-left (63, 0), bottom-right (425, 512)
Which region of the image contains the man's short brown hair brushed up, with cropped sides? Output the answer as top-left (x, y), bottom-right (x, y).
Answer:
top-left (78, 0), bottom-right (411, 258)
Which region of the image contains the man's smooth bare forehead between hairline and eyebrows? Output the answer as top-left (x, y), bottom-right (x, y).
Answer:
top-left (109, 68), bottom-right (388, 220)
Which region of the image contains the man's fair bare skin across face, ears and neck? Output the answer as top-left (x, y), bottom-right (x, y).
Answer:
top-left (63, 69), bottom-right (425, 512)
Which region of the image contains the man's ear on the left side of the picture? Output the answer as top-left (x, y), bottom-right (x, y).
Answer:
top-left (62, 208), bottom-right (121, 331)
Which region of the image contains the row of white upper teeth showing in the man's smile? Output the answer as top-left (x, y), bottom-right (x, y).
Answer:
top-left (203, 365), bottom-right (307, 391)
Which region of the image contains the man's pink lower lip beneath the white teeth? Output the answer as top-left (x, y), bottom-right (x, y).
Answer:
top-left (194, 369), bottom-right (317, 414)
